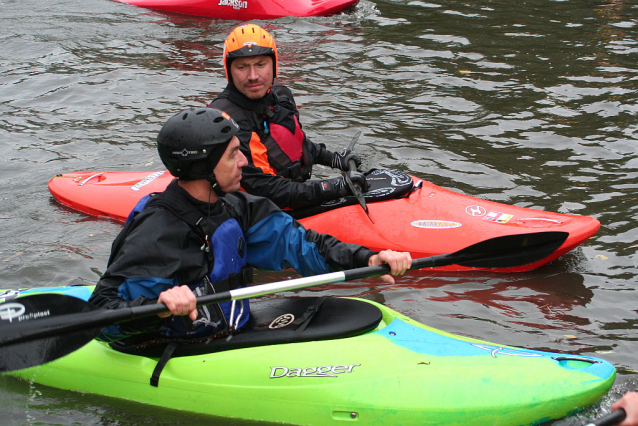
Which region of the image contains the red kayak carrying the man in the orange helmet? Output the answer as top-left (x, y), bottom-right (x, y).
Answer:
top-left (49, 170), bottom-right (600, 272)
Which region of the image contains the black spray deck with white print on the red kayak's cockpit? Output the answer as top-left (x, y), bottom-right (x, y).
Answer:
top-left (287, 169), bottom-right (414, 219)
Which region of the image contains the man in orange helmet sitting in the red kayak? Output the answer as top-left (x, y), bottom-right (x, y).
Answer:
top-left (209, 24), bottom-right (368, 209)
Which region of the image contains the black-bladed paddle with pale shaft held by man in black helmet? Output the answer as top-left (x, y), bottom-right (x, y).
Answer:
top-left (0, 232), bottom-right (569, 372)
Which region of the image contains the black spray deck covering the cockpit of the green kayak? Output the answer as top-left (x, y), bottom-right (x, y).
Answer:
top-left (111, 297), bottom-right (382, 357)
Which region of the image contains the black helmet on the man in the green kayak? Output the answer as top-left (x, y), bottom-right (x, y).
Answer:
top-left (157, 108), bottom-right (239, 180)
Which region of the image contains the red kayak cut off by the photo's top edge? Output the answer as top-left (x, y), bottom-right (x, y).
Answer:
top-left (117, 0), bottom-right (359, 21)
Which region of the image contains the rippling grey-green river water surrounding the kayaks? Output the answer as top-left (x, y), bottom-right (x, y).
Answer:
top-left (0, 0), bottom-right (638, 426)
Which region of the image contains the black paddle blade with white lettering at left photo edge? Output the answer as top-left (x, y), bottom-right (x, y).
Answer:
top-left (0, 294), bottom-right (103, 372)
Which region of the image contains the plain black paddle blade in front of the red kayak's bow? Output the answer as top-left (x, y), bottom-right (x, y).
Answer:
top-left (454, 232), bottom-right (569, 268)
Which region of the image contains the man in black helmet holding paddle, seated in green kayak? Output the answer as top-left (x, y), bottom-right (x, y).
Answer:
top-left (89, 108), bottom-right (411, 344)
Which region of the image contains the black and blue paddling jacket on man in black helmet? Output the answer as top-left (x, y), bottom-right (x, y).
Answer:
top-left (89, 180), bottom-right (373, 340)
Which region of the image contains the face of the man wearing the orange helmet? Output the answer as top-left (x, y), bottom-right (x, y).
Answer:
top-left (230, 55), bottom-right (273, 99)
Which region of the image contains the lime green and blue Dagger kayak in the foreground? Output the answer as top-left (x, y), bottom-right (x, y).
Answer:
top-left (0, 286), bottom-right (615, 426)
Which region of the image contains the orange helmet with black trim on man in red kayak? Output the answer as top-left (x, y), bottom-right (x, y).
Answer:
top-left (224, 24), bottom-right (279, 81)
